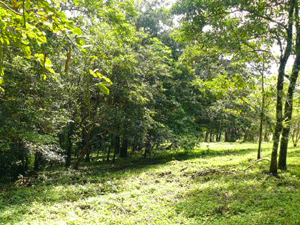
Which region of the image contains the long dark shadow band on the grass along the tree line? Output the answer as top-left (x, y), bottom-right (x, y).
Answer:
top-left (0, 144), bottom-right (268, 222)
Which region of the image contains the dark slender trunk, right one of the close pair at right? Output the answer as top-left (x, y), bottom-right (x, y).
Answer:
top-left (278, 2), bottom-right (300, 170)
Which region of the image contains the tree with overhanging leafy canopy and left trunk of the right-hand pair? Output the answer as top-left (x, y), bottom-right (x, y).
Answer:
top-left (175, 0), bottom-right (296, 175)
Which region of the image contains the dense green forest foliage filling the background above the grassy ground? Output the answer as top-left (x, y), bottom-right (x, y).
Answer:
top-left (0, 0), bottom-right (300, 182)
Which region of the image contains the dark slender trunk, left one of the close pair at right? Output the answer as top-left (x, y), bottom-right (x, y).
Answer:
top-left (270, 0), bottom-right (296, 175)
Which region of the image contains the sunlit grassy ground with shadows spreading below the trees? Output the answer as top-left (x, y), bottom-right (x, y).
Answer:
top-left (0, 143), bottom-right (300, 225)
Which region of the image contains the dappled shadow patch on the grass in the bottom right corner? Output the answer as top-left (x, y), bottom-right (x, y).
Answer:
top-left (174, 165), bottom-right (300, 225)
